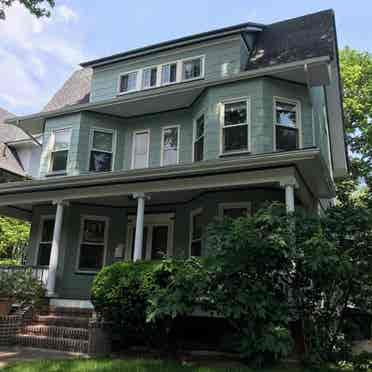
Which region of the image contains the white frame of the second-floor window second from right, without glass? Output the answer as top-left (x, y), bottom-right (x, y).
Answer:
top-left (220, 97), bottom-right (252, 156)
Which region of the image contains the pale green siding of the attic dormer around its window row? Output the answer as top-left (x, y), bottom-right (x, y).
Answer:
top-left (90, 36), bottom-right (243, 102)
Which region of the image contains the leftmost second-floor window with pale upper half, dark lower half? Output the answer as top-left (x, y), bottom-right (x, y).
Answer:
top-left (50, 128), bottom-right (71, 172)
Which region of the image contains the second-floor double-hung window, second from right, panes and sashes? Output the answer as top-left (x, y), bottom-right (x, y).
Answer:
top-left (221, 100), bottom-right (249, 153)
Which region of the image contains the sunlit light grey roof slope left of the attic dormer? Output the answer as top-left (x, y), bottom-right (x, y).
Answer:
top-left (43, 68), bottom-right (92, 111)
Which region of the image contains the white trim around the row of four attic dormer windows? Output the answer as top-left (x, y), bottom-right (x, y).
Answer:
top-left (116, 54), bottom-right (206, 96)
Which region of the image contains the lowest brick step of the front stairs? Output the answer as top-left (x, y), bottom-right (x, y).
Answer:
top-left (15, 333), bottom-right (88, 353)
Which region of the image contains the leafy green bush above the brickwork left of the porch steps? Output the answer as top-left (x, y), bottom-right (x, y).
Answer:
top-left (0, 269), bottom-right (45, 307)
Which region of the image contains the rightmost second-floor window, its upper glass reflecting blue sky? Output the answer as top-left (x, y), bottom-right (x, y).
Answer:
top-left (274, 98), bottom-right (299, 151)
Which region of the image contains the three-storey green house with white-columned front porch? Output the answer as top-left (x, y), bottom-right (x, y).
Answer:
top-left (0, 11), bottom-right (347, 306)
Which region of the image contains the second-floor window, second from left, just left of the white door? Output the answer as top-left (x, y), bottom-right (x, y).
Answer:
top-left (89, 129), bottom-right (114, 172)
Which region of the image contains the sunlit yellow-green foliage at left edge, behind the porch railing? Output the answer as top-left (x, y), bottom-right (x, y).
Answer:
top-left (0, 217), bottom-right (30, 260)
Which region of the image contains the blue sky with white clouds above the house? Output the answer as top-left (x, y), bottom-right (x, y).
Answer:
top-left (0, 0), bottom-right (372, 114)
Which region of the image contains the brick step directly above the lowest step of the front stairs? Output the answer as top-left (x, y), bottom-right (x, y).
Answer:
top-left (23, 324), bottom-right (89, 340)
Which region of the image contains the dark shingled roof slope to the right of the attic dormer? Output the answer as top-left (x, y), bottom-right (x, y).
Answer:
top-left (246, 10), bottom-right (336, 70)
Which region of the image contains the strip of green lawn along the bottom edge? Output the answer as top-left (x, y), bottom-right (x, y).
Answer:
top-left (3, 359), bottom-right (348, 372)
